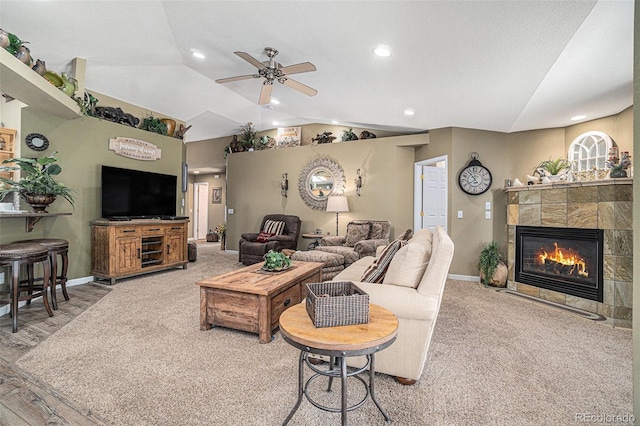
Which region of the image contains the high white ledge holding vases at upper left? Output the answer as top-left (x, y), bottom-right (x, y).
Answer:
top-left (0, 49), bottom-right (82, 119)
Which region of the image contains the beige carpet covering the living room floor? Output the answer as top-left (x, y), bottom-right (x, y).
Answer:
top-left (17, 244), bottom-right (632, 425)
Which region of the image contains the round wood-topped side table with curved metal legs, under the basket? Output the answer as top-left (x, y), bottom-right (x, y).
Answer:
top-left (280, 303), bottom-right (398, 425)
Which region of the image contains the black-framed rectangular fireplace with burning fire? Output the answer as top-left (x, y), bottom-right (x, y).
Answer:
top-left (515, 226), bottom-right (604, 302)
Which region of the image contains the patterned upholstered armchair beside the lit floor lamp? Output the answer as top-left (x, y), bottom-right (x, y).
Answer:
top-left (316, 220), bottom-right (391, 268)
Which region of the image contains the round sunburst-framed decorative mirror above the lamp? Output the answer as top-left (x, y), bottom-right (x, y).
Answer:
top-left (298, 158), bottom-right (345, 210)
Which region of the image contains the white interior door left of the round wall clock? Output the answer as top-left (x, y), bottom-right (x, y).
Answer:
top-left (413, 156), bottom-right (448, 232)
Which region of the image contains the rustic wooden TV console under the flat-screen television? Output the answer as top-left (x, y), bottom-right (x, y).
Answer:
top-left (91, 219), bottom-right (189, 284)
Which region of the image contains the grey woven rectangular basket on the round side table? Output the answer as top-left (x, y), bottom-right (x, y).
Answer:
top-left (306, 281), bottom-right (369, 328)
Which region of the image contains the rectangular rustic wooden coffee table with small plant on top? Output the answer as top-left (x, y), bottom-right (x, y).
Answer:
top-left (196, 261), bottom-right (323, 343)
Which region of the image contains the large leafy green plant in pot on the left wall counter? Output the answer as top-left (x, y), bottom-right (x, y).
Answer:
top-left (0, 152), bottom-right (75, 213)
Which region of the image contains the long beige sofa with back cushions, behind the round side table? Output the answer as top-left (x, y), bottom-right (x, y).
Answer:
top-left (333, 227), bottom-right (453, 384)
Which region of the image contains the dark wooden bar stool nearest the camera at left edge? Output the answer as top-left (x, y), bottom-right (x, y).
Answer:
top-left (0, 243), bottom-right (53, 333)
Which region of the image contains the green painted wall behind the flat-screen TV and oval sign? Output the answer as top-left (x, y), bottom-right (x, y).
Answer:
top-left (0, 110), bottom-right (186, 279)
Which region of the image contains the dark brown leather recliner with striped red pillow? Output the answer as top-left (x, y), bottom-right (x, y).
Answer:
top-left (238, 214), bottom-right (302, 265)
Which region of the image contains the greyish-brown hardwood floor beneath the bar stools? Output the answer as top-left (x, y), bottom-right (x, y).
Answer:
top-left (0, 283), bottom-right (111, 426)
